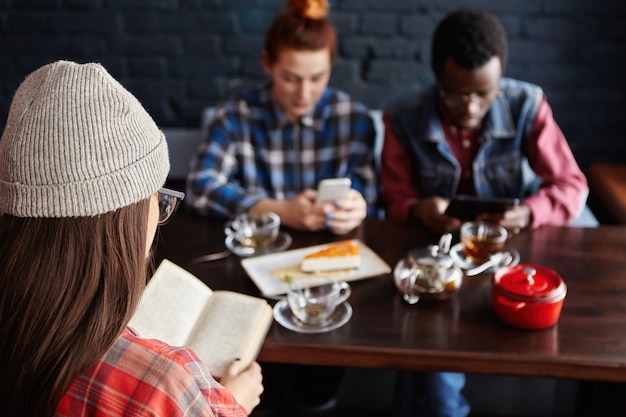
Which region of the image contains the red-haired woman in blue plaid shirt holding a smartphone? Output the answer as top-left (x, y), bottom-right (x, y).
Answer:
top-left (187, 0), bottom-right (377, 234)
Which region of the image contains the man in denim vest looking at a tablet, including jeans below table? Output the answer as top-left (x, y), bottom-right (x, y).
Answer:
top-left (381, 11), bottom-right (588, 417)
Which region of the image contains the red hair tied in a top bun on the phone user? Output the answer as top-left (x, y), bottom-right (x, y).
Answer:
top-left (265, 0), bottom-right (337, 63)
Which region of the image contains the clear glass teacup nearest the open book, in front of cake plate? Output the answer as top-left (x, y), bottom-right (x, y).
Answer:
top-left (287, 277), bottom-right (351, 327)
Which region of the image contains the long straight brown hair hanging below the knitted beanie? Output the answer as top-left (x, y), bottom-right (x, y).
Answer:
top-left (0, 199), bottom-right (149, 416)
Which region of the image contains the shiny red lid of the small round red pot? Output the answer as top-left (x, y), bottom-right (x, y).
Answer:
top-left (493, 264), bottom-right (566, 302)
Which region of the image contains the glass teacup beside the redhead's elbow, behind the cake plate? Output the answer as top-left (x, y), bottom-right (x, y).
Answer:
top-left (224, 212), bottom-right (280, 253)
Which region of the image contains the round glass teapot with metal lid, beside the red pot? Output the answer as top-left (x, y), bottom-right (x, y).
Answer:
top-left (393, 233), bottom-right (463, 304)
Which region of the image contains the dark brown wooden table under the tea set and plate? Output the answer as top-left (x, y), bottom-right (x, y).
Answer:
top-left (156, 212), bottom-right (626, 381)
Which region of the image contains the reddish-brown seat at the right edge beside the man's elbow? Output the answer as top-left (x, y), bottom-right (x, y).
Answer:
top-left (588, 163), bottom-right (626, 224)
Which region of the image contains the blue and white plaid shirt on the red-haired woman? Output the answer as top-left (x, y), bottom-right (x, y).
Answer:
top-left (185, 85), bottom-right (378, 219)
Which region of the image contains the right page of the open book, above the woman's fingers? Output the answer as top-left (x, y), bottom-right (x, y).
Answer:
top-left (188, 291), bottom-right (273, 377)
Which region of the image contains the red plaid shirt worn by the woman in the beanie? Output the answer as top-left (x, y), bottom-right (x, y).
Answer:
top-left (56, 329), bottom-right (247, 417)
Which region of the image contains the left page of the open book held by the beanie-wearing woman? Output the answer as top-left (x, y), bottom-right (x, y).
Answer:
top-left (129, 259), bottom-right (213, 346)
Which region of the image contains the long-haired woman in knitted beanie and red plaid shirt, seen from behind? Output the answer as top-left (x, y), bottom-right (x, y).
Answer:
top-left (0, 61), bottom-right (263, 416)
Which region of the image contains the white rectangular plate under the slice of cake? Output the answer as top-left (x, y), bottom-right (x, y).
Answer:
top-left (241, 239), bottom-right (391, 296)
